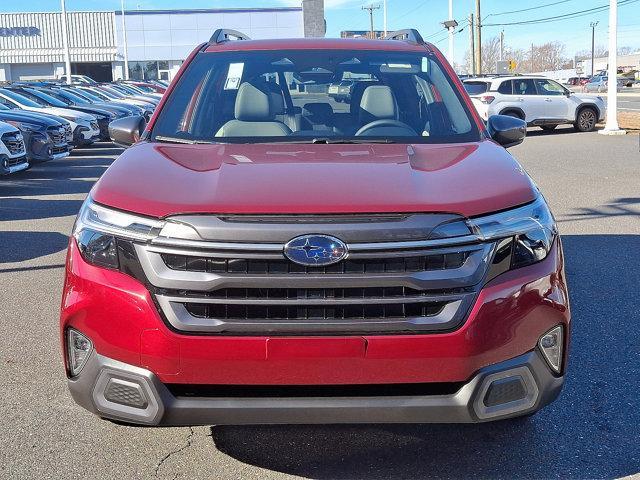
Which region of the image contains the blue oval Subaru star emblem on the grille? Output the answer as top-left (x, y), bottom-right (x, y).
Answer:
top-left (284, 235), bottom-right (347, 267)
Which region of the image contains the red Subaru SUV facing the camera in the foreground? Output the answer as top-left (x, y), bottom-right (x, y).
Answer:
top-left (60, 30), bottom-right (570, 425)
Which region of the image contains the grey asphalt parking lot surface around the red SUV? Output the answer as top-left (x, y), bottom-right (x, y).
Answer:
top-left (0, 127), bottom-right (640, 479)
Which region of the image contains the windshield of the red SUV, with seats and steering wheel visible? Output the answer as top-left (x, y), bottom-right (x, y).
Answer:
top-left (152, 50), bottom-right (480, 143)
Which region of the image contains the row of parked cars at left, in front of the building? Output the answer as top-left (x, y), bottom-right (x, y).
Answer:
top-left (0, 77), bottom-right (166, 175)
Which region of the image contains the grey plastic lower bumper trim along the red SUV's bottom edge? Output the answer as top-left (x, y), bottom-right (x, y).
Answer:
top-left (68, 350), bottom-right (564, 426)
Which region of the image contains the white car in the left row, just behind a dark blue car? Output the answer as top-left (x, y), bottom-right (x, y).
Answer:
top-left (0, 88), bottom-right (100, 145)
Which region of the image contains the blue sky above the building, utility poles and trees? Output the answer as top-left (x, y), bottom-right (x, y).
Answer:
top-left (5, 0), bottom-right (640, 63)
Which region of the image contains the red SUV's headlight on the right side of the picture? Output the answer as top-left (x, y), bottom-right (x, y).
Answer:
top-left (468, 196), bottom-right (557, 268)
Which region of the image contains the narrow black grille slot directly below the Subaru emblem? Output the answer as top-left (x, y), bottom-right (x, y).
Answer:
top-left (162, 252), bottom-right (469, 275)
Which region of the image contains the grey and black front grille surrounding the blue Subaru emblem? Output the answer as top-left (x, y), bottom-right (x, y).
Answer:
top-left (132, 214), bottom-right (494, 335)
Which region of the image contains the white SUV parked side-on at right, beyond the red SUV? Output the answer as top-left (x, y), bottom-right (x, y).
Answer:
top-left (463, 76), bottom-right (606, 132)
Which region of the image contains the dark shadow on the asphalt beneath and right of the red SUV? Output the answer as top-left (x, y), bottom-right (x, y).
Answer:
top-left (211, 235), bottom-right (640, 479)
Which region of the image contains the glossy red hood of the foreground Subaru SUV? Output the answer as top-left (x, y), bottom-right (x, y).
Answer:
top-left (91, 140), bottom-right (536, 217)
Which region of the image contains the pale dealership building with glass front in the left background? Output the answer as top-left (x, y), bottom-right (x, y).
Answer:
top-left (0, 0), bottom-right (325, 81)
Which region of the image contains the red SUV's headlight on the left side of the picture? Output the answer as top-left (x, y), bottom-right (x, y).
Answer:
top-left (73, 197), bottom-right (165, 269)
